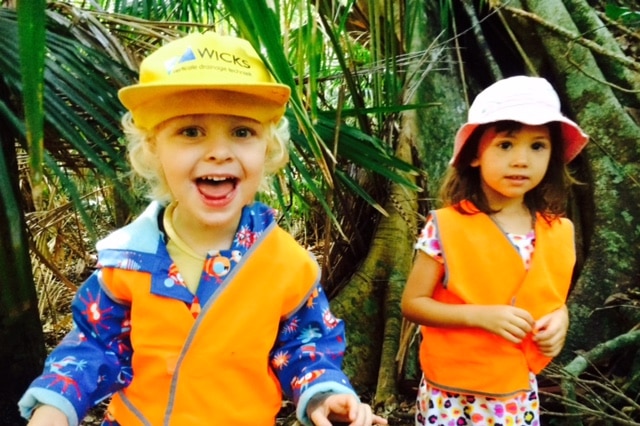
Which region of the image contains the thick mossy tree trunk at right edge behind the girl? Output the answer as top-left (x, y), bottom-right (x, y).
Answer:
top-left (526, 1), bottom-right (640, 362)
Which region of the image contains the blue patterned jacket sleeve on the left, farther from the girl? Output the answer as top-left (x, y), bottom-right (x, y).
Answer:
top-left (18, 271), bottom-right (132, 425)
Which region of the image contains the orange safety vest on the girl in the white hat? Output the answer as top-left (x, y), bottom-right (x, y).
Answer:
top-left (420, 207), bottom-right (575, 398)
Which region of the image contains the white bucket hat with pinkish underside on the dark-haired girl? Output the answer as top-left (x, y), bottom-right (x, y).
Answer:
top-left (451, 75), bottom-right (589, 165)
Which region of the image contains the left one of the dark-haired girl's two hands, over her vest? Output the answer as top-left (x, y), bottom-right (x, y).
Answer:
top-left (473, 305), bottom-right (534, 344)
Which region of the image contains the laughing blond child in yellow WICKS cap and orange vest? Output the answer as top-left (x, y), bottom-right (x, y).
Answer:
top-left (20, 33), bottom-right (387, 426)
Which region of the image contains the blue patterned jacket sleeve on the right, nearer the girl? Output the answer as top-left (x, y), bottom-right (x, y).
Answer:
top-left (271, 283), bottom-right (357, 425)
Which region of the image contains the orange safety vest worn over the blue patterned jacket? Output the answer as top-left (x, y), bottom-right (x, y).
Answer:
top-left (103, 227), bottom-right (319, 426)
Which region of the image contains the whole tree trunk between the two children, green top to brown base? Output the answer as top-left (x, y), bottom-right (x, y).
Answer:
top-left (332, 1), bottom-right (464, 409)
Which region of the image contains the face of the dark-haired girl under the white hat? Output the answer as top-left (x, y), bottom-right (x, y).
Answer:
top-left (471, 124), bottom-right (551, 208)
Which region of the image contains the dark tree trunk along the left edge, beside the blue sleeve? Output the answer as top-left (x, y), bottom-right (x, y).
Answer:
top-left (0, 123), bottom-right (45, 426)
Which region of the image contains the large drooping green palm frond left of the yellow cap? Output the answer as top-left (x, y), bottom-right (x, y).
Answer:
top-left (0, 9), bottom-right (135, 240)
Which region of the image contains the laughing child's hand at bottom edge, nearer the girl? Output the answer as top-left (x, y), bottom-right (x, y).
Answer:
top-left (307, 394), bottom-right (387, 426)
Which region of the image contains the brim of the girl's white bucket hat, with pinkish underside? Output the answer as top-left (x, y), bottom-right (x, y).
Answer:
top-left (450, 108), bottom-right (589, 165)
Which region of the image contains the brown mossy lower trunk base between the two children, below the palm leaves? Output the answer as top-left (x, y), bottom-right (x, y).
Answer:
top-left (331, 179), bottom-right (413, 392)
